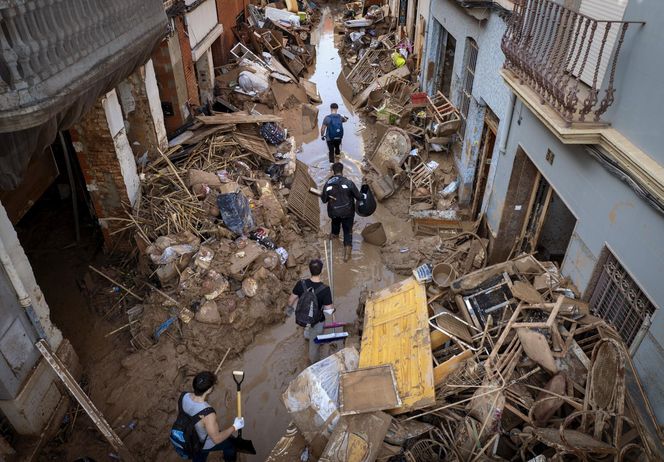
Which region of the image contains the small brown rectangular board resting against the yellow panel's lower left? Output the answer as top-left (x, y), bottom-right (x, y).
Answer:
top-left (339, 364), bottom-right (401, 415)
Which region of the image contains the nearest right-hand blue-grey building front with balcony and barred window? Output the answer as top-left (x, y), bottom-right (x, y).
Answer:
top-left (485, 0), bottom-right (664, 422)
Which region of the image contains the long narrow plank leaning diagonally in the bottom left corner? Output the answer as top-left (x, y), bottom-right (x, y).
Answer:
top-left (35, 339), bottom-right (135, 462)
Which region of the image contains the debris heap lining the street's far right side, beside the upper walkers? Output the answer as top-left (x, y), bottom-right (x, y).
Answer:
top-left (336, 8), bottom-right (472, 235)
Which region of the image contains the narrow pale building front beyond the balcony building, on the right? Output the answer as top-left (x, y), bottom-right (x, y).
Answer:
top-left (420, 0), bottom-right (510, 219)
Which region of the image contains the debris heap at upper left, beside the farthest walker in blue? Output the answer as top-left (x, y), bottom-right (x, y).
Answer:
top-left (189, 0), bottom-right (321, 142)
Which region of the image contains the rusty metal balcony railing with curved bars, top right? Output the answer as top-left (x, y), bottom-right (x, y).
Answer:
top-left (502, 0), bottom-right (644, 125)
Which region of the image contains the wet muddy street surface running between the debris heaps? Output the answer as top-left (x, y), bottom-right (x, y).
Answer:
top-left (210, 8), bottom-right (411, 461)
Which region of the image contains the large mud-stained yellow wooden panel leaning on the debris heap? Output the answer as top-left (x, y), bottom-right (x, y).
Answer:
top-left (359, 278), bottom-right (435, 414)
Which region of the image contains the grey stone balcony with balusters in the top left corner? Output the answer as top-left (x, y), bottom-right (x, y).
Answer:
top-left (0, 0), bottom-right (166, 188)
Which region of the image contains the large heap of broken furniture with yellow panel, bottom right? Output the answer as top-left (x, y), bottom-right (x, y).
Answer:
top-left (267, 255), bottom-right (662, 462)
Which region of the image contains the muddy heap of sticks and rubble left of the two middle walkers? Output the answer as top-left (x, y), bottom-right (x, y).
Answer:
top-left (102, 123), bottom-right (319, 364)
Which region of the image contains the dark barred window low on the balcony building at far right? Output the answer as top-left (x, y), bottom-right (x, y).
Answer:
top-left (590, 250), bottom-right (655, 346)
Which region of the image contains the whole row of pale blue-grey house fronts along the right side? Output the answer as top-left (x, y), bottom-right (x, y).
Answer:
top-left (420, 0), bottom-right (664, 422)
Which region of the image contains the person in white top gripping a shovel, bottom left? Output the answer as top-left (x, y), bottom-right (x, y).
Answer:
top-left (171, 371), bottom-right (244, 462)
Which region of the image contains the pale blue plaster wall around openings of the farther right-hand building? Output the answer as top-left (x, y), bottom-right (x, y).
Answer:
top-left (421, 0), bottom-right (510, 205)
